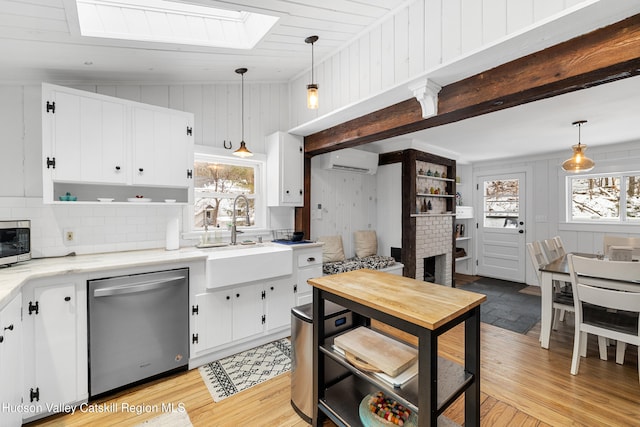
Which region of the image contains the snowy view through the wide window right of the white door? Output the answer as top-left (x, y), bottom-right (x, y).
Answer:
top-left (569, 175), bottom-right (640, 222)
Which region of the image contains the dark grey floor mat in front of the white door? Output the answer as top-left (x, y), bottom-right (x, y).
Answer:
top-left (459, 277), bottom-right (540, 334)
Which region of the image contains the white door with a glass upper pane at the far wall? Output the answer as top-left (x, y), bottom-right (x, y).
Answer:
top-left (476, 172), bottom-right (526, 283)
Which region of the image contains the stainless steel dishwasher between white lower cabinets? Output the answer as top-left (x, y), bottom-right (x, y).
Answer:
top-left (88, 269), bottom-right (189, 397)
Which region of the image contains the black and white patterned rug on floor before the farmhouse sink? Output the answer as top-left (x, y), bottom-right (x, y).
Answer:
top-left (199, 338), bottom-right (291, 402)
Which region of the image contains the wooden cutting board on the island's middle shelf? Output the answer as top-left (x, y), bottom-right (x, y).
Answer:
top-left (334, 326), bottom-right (418, 377)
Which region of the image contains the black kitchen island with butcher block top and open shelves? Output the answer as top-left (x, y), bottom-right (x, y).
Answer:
top-left (308, 269), bottom-right (486, 427)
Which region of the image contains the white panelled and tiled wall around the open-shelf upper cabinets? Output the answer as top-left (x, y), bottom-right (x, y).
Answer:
top-left (0, 82), bottom-right (293, 256)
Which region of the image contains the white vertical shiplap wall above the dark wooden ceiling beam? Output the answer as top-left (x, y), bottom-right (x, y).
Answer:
top-left (290, 0), bottom-right (585, 127)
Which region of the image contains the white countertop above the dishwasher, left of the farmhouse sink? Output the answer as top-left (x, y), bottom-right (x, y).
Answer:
top-left (0, 247), bottom-right (207, 309)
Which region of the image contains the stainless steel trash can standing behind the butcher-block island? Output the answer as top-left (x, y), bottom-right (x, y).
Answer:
top-left (291, 301), bottom-right (353, 423)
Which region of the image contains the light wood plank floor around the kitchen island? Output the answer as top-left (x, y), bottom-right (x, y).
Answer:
top-left (31, 300), bottom-right (640, 427)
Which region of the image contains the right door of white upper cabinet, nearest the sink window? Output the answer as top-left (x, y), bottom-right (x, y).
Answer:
top-left (132, 106), bottom-right (193, 187)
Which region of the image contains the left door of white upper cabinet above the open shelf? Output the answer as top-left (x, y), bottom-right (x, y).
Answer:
top-left (42, 85), bottom-right (127, 184)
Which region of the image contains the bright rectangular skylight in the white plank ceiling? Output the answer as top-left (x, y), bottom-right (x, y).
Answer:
top-left (76, 0), bottom-right (278, 49)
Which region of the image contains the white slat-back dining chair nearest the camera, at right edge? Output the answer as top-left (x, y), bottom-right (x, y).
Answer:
top-left (567, 254), bottom-right (640, 381)
